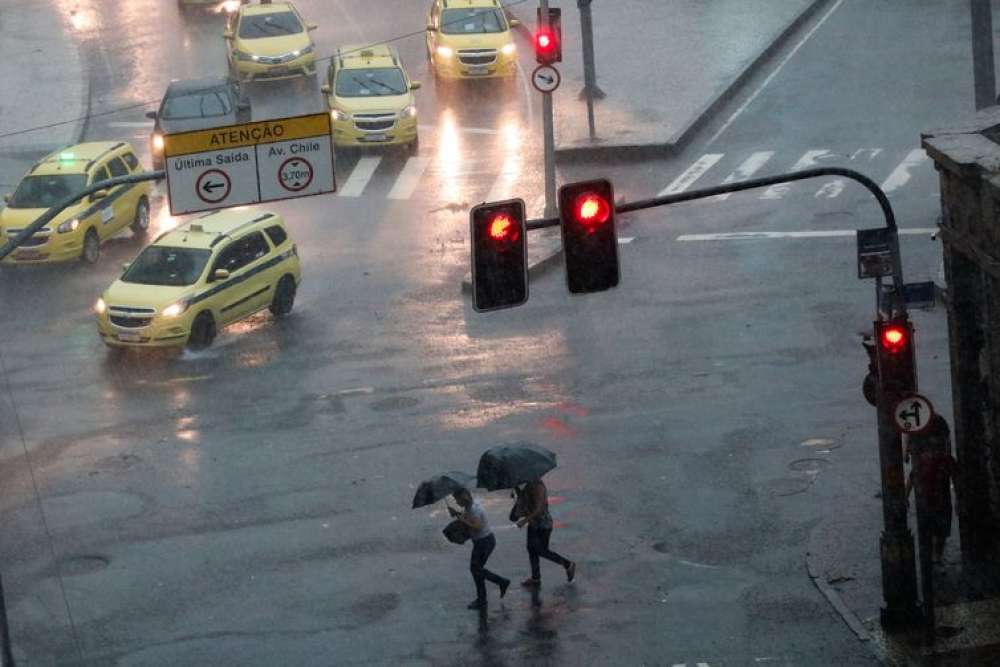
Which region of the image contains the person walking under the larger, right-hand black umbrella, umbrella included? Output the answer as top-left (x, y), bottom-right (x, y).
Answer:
top-left (476, 443), bottom-right (576, 587)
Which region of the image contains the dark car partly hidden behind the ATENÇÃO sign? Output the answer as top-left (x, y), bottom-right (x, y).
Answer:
top-left (146, 79), bottom-right (250, 169)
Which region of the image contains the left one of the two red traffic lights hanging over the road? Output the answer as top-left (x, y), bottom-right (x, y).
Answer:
top-left (469, 199), bottom-right (528, 312)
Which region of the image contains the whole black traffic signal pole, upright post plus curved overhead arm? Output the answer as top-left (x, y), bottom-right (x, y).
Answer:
top-left (526, 167), bottom-right (930, 632)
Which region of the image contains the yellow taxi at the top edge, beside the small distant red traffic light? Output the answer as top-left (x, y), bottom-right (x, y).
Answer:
top-left (427, 0), bottom-right (521, 79)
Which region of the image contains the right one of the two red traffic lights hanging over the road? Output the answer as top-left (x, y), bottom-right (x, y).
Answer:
top-left (559, 179), bottom-right (619, 294)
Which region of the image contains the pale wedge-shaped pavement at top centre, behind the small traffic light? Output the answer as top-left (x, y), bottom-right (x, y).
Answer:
top-left (510, 0), bottom-right (826, 159)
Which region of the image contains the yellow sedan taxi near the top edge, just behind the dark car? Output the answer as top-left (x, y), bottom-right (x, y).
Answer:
top-left (223, 2), bottom-right (318, 81)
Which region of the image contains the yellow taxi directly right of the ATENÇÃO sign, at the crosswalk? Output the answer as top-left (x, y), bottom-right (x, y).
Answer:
top-left (322, 44), bottom-right (420, 152)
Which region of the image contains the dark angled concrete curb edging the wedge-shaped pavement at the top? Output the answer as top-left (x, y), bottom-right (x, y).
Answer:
top-left (556, 0), bottom-right (830, 162)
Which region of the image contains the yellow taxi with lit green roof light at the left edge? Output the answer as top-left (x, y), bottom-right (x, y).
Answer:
top-left (0, 141), bottom-right (152, 264)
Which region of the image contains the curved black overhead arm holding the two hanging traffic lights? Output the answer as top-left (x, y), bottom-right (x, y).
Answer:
top-left (527, 167), bottom-right (906, 315)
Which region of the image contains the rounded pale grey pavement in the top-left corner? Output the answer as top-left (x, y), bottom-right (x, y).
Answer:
top-left (0, 0), bottom-right (90, 192)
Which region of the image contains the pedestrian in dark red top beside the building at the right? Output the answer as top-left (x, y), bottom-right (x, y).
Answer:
top-left (906, 415), bottom-right (958, 563)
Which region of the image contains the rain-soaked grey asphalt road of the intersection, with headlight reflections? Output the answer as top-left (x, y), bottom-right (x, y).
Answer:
top-left (0, 0), bottom-right (963, 666)
